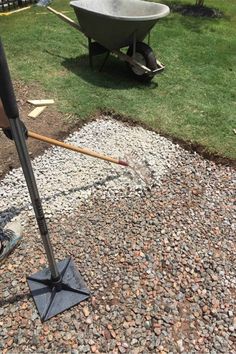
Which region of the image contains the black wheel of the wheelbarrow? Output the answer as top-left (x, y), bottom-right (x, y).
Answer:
top-left (127, 42), bottom-right (157, 82)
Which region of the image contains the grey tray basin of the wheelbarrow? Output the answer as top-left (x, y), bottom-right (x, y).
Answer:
top-left (70, 0), bottom-right (170, 51)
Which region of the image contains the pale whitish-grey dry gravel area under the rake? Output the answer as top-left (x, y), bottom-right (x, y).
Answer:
top-left (0, 119), bottom-right (179, 224)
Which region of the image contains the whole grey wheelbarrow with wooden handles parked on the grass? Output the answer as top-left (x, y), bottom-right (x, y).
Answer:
top-left (47, 0), bottom-right (170, 81)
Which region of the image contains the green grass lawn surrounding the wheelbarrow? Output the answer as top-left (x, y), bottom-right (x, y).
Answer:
top-left (0, 0), bottom-right (236, 158)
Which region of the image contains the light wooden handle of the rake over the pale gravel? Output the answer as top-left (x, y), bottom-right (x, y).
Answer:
top-left (28, 131), bottom-right (129, 167)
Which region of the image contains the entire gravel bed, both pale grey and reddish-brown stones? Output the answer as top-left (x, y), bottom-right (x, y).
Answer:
top-left (0, 118), bottom-right (236, 354)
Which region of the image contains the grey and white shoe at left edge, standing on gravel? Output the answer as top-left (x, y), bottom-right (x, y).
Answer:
top-left (0, 218), bottom-right (22, 264)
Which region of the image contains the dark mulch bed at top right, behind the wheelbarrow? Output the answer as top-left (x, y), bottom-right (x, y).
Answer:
top-left (170, 3), bottom-right (223, 18)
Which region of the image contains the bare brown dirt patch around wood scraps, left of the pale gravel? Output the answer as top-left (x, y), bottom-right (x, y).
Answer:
top-left (0, 82), bottom-right (71, 178)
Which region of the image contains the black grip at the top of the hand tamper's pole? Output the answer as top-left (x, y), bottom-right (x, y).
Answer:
top-left (0, 38), bottom-right (19, 119)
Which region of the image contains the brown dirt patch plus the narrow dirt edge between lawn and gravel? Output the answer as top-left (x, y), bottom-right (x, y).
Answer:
top-left (0, 82), bottom-right (236, 179)
